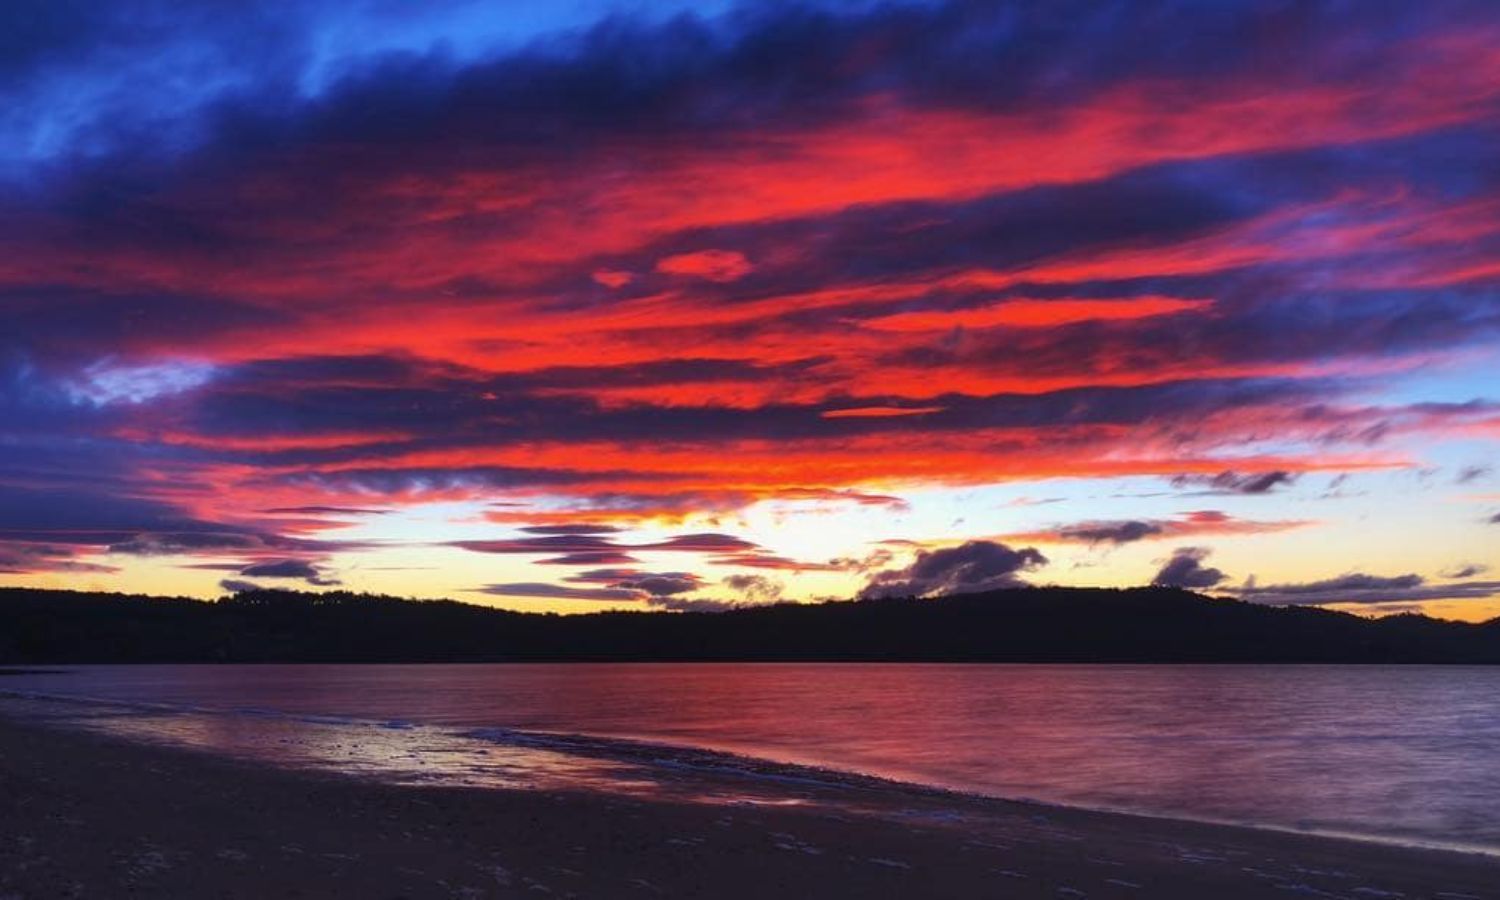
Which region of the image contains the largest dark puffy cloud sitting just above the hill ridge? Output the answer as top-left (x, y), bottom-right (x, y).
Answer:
top-left (860, 540), bottom-right (1047, 600)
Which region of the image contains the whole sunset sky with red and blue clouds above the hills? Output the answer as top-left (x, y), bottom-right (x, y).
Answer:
top-left (0, 0), bottom-right (1500, 620)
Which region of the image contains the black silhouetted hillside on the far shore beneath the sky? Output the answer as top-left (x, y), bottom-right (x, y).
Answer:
top-left (0, 588), bottom-right (1500, 663)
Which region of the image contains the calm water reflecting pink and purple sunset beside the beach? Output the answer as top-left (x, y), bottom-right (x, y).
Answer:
top-left (0, 665), bottom-right (1500, 851)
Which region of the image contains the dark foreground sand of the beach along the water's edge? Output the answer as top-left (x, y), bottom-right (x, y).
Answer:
top-left (0, 719), bottom-right (1500, 900)
